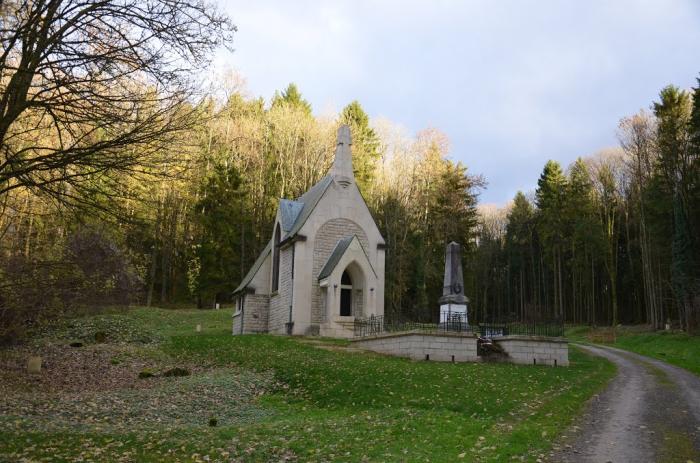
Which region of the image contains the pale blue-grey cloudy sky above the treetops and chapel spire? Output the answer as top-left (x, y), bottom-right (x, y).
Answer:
top-left (216, 0), bottom-right (700, 204)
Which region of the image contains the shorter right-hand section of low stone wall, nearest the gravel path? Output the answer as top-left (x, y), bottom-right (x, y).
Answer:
top-left (494, 336), bottom-right (569, 367)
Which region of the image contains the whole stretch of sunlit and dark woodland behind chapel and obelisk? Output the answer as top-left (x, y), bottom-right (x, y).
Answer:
top-left (0, 0), bottom-right (700, 340)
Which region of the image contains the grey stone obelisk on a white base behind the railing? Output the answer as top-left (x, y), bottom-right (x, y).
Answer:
top-left (438, 241), bottom-right (469, 323)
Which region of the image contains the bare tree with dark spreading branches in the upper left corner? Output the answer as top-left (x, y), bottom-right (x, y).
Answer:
top-left (0, 0), bottom-right (236, 202)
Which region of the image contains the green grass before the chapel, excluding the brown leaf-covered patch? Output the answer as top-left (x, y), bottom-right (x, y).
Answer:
top-left (0, 309), bottom-right (614, 461)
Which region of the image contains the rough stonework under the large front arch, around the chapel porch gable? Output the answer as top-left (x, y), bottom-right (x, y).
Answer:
top-left (311, 218), bottom-right (369, 323)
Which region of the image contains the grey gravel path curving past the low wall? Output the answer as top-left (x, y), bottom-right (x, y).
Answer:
top-left (549, 346), bottom-right (700, 463)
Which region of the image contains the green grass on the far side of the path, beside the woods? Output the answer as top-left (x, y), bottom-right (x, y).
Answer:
top-left (567, 326), bottom-right (700, 375)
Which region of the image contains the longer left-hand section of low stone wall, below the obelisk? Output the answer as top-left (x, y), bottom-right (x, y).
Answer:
top-left (351, 331), bottom-right (480, 362)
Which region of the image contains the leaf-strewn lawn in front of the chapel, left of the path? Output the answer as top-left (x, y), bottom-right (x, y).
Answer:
top-left (0, 308), bottom-right (614, 462)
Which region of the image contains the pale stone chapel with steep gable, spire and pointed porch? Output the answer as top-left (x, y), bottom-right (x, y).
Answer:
top-left (233, 125), bottom-right (385, 337)
